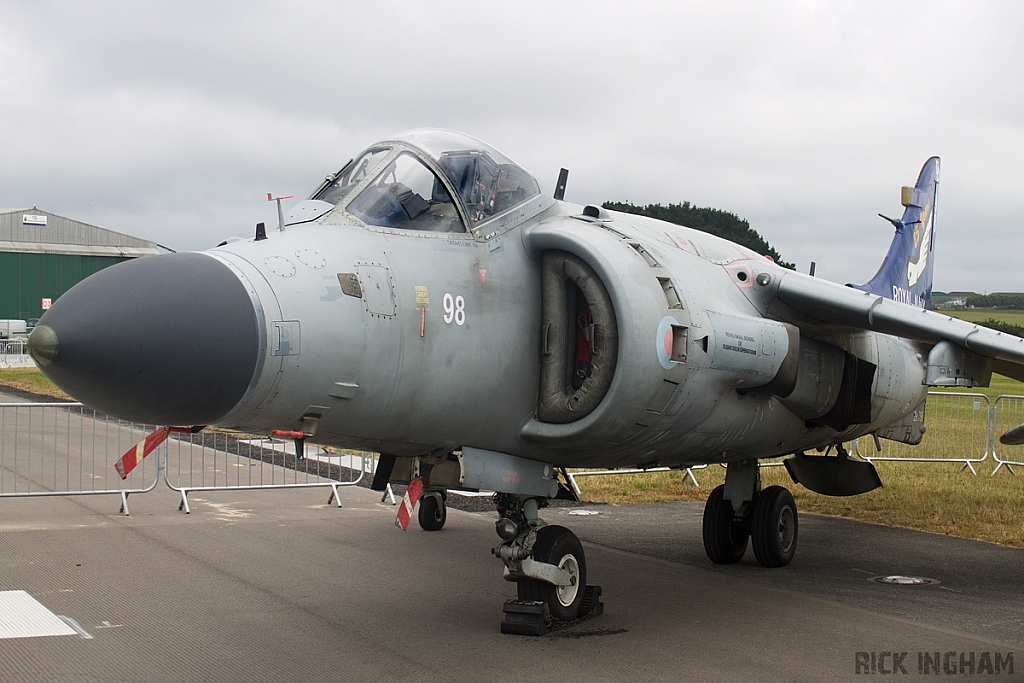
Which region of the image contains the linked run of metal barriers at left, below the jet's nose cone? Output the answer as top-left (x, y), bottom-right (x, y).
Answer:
top-left (0, 402), bottom-right (373, 514)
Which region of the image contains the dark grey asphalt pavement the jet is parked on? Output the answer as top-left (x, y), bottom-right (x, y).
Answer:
top-left (0, 487), bottom-right (1024, 683)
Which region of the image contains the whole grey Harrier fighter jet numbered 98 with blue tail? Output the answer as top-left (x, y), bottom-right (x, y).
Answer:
top-left (29, 130), bottom-right (1024, 621)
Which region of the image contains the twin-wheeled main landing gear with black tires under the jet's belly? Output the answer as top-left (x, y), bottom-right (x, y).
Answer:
top-left (703, 460), bottom-right (798, 567)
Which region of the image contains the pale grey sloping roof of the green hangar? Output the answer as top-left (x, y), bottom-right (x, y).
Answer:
top-left (0, 207), bottom-right (160, 257)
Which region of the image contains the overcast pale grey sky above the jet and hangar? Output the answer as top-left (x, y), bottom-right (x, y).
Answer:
top-left (0, 0), bottom-right (1024, 292)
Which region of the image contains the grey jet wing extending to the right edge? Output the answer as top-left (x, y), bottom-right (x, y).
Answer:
top-left (777, 272), bottom-right (1024, 381)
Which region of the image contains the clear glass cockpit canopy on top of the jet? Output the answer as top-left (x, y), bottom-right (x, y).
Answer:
top-left (311, 129), bottom-right (541, 232)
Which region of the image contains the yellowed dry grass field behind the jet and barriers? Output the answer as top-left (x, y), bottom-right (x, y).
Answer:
top-left (6, 368), bottom-right (1024, 548)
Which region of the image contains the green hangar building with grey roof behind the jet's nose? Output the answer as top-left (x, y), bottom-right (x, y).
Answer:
top-left (0, 207), bottom-right (160, 321)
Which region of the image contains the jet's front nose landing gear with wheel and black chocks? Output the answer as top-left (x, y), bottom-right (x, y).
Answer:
top-left (492, 494), bottom-right (604, 636)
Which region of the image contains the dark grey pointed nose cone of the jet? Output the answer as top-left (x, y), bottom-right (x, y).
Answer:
top-left (35, 253), bottom-right (260, 425)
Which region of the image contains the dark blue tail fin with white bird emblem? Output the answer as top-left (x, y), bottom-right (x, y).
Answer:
top-left (850, 157), bottom-right (939, 308)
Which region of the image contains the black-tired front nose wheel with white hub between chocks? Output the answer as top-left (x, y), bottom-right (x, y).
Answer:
top-left (516, 526), bottom-right (587, 622)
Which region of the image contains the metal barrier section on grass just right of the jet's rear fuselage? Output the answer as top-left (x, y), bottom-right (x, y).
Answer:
top-left (853, 391), bottom-right (992, 474)
